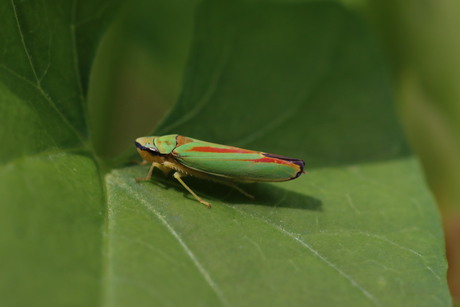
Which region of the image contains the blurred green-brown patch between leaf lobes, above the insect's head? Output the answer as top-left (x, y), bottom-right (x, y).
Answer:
top-left (88, 0), bottom-right (198, 159)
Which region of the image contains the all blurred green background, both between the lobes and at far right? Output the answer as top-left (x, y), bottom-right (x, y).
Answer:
top-left (89, 0), bottom-right (460, 300)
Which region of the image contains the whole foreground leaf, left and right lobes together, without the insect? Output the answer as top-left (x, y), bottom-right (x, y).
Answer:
top-left (0, 1), bottom-right (450, 306)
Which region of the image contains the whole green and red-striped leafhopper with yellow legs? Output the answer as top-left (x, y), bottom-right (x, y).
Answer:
top-left (135, 134), bottom-right (305, 208)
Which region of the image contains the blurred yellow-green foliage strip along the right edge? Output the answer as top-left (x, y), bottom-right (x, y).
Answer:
top-left (369, 1), bottom-right (460, 305)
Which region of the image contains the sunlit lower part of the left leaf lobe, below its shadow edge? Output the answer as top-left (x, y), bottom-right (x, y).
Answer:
top-left (0, 152), bottom-right (105, 306)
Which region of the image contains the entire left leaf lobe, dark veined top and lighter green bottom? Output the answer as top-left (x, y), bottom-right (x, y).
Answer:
top-left (0, 0), bottom-right (117, 306)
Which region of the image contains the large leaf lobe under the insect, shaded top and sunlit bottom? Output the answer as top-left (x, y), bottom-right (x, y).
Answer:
top-left (106, 2), bottom-right (450, 306)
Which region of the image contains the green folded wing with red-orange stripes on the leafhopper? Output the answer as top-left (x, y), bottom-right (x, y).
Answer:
top-left (172, 140), bottom-right (304, 181)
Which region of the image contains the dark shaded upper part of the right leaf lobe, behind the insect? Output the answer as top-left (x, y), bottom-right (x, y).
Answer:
top-left (156, 0), bottom-right (408, 167)
